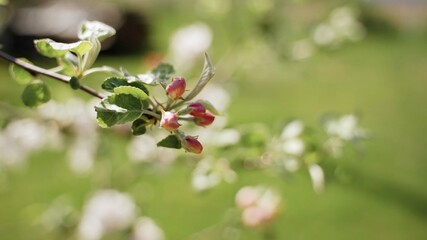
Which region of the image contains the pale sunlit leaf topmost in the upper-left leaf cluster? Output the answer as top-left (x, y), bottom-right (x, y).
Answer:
top-left (78, 21), bottom-right (116, 42)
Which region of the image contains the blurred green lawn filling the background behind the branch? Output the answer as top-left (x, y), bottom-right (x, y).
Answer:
top-left (0, 2), bottom-right (427, 240)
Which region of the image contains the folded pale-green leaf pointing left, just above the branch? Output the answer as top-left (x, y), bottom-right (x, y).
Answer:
top-left (34, 38), bottom-right (92, 58)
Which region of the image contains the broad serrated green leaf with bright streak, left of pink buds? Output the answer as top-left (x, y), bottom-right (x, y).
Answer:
top-left (95, 94), bottom-right (143, 128)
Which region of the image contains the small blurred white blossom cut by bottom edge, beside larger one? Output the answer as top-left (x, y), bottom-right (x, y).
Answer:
top-left (132, 217), bottom-right (165, 240)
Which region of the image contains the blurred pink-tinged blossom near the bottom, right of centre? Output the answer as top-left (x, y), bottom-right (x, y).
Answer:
top-left (236, 186), bottom-right (281, 227)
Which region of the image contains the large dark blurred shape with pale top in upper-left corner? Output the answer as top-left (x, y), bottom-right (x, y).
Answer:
top-left (0, 0), bottom-right (149, 55)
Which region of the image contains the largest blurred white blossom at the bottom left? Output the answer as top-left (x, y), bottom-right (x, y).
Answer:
top-left (78, 190), bottom-right (137, 240)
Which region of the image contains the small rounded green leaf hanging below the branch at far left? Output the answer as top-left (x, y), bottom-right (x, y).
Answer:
top-left (21, 80), bottom-right (50, 107)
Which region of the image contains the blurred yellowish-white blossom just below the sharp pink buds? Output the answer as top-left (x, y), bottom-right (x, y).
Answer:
top-left (191, 158), bottom-right (237, 191)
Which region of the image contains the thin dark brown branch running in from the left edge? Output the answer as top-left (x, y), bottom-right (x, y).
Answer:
top-left (0, 50), bottom-right (104, 99)
